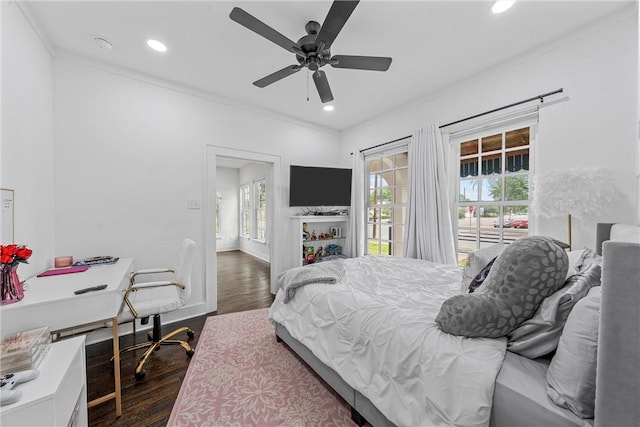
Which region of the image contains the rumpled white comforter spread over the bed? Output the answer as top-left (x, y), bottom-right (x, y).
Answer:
top-left (269, 256), bottom-right (506, 427)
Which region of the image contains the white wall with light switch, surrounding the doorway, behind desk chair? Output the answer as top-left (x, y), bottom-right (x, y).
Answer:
top-left (54, 59), bottom-right (339, 315)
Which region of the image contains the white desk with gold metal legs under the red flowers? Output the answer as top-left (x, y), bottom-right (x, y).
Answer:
top-left (0, 258), bottom-right (133, 416)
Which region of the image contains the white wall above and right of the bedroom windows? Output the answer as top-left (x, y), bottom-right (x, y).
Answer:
top-left (341, 5), bottom-right (638, 252)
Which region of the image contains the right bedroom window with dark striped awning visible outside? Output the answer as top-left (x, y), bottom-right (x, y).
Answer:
top-left (456, 126), bottom-right (532, 261)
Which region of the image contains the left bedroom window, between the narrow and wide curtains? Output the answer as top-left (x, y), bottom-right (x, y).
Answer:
top-left (366, 151), bottom-right (409, 256)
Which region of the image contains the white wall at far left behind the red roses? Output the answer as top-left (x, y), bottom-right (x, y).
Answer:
top-left (0, 1), bottom-right (54, 279)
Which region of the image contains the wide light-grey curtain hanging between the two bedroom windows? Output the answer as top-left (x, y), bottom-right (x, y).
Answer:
top-left (404, 125), bottom-right (456, 264)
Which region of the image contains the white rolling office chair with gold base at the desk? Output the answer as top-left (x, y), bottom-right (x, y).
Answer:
top-left (118, 239), bottom-right (196, 379)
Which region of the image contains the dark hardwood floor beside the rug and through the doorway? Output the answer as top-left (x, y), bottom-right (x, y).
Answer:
top-left (86, 251), bottom-right (273, 427)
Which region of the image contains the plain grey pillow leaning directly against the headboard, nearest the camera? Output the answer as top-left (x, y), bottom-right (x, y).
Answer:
top-left (547, 286), bottom-right (600, 418)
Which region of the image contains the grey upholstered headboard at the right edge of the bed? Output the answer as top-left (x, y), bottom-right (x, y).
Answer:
top-left (595, 224), bottom-right (640, 427)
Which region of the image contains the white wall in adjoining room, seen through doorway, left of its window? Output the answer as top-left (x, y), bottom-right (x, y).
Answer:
top-left (216, 167), bottom-right (240, 252)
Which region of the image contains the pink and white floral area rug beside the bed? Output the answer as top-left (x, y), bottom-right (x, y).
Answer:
top-left (167, 309), bottom-right (355, 427)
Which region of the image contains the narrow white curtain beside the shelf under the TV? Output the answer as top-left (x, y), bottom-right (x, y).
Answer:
top-left (347, 150), bottom-right (367, 257)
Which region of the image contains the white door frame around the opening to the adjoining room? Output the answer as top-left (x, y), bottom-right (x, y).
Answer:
top-left (203, 146), bottom-right (281, 313)
